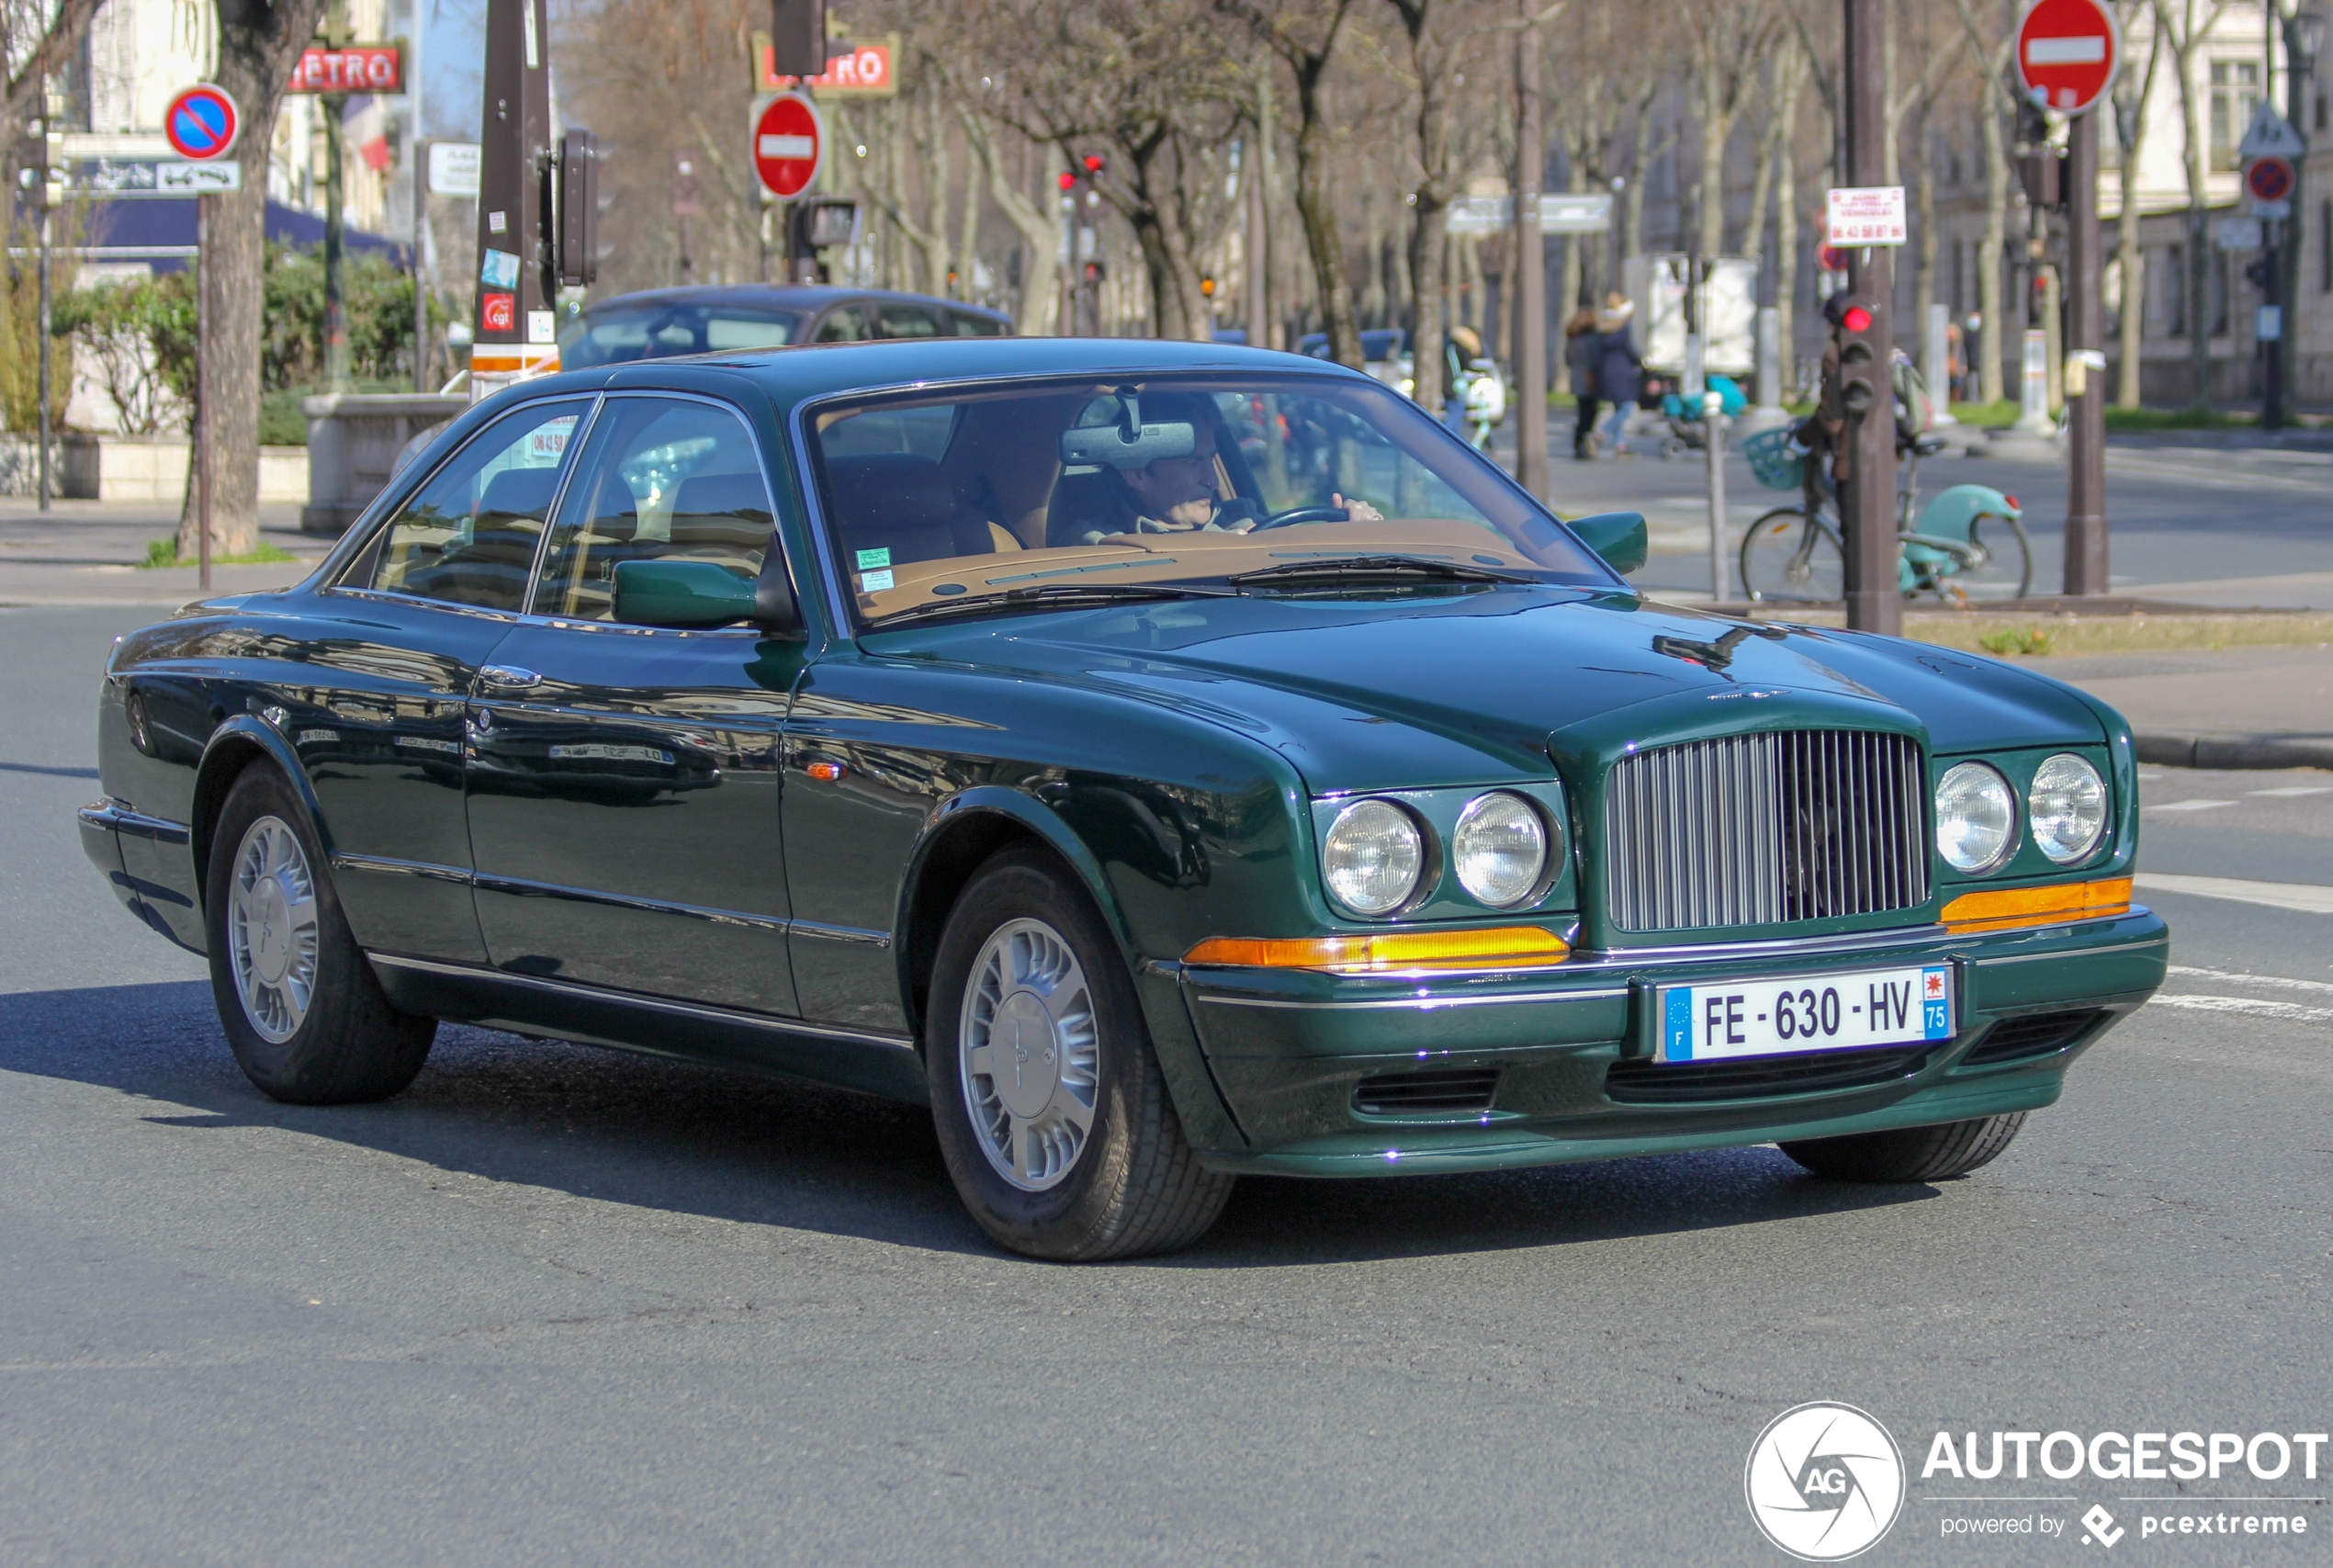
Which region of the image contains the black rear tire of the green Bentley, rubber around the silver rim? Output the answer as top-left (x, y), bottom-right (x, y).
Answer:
top-left (203, 763), bottom-right (436, 1106)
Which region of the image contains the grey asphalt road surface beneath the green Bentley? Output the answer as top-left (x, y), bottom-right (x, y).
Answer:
top-left (0, 609), bottom-right (2333, 1568)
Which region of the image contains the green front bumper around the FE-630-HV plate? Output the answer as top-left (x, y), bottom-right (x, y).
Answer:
top-left (1155, 908), bottom-right (2170, 1176)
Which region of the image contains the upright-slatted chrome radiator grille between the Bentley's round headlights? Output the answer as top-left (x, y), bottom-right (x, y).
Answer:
top-left (1606, 730), bottom-right (1927, 931)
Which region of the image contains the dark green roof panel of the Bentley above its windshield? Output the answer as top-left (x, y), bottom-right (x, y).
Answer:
top-left (513, 338), bottom-right (1377, 403)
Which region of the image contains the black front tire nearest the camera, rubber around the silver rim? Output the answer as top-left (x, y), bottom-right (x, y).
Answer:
top-left (924, 850), bottom-right (1234, 1262)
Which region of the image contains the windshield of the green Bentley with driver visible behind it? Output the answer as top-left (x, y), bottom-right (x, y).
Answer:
top-left (817, 373), bottom-right (1617, 626)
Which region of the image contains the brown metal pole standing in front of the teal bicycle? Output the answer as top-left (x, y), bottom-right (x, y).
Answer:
top-left (1839, 0), bottom-right (1904, 637)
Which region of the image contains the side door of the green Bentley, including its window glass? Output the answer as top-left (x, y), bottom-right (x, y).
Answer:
top-left (469, 392), bottom-right (800, 1015)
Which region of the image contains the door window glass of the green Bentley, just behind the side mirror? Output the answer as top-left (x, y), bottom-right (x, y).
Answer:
top-left (535, 397), bottom-right (774, 621)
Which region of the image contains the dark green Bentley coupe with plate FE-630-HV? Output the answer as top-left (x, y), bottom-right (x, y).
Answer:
top-left (79, 338), bottom-right (2168, 1258)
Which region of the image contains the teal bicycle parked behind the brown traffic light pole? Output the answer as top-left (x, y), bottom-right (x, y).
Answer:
top-left (1741, 427), bottom-right (2034, 604)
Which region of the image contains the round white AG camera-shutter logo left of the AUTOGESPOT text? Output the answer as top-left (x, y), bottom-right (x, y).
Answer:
top-left (1742, 1400), bottom-right (1904, 1563)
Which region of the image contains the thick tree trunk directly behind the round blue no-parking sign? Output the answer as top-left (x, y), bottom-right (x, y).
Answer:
top-left (177, 0), bottom-right (324, 560)
